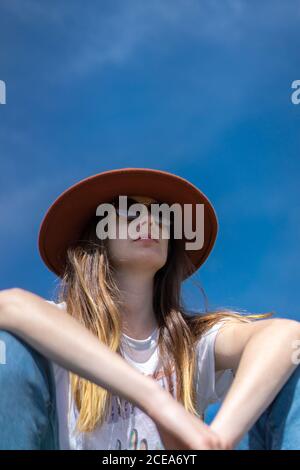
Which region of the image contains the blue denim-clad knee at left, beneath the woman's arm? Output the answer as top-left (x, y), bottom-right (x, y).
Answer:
top-left (0, 330), bottom-right (58, 450)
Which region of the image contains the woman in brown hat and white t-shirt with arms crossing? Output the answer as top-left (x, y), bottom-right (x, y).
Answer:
top-left (0, 169), bottom-right (300, 449)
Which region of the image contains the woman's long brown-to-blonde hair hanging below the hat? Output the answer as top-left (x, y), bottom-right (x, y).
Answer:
top-left (58, 218), bottom-right (273, 432)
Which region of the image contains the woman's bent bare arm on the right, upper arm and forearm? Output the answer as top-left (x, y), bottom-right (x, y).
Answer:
top-left (211, 318), bottom-right (300, 447)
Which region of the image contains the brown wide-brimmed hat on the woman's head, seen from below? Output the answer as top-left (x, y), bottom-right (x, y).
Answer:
top-left (38, 168), bottom-right (218, 277)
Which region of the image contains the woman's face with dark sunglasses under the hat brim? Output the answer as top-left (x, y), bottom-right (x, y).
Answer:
top-left (107, 196), bottom-right (169, 276)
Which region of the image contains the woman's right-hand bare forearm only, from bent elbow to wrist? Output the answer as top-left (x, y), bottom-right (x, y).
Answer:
top-left (211, 321), bottom-right (300, 447)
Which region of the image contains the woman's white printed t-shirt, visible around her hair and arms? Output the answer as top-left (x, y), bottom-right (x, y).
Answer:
top-left (47, 301), bottom-right (234, 450)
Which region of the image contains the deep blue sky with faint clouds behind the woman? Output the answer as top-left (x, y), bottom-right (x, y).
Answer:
top-left (0, 0), bottom-right (300, 430)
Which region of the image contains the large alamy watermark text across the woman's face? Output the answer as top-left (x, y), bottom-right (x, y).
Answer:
top-left (96, 196), bottom-right (204, 250)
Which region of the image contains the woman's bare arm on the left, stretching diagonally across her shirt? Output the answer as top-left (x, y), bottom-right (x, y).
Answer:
top-left (0, 289), bottom-right (224, 449)
